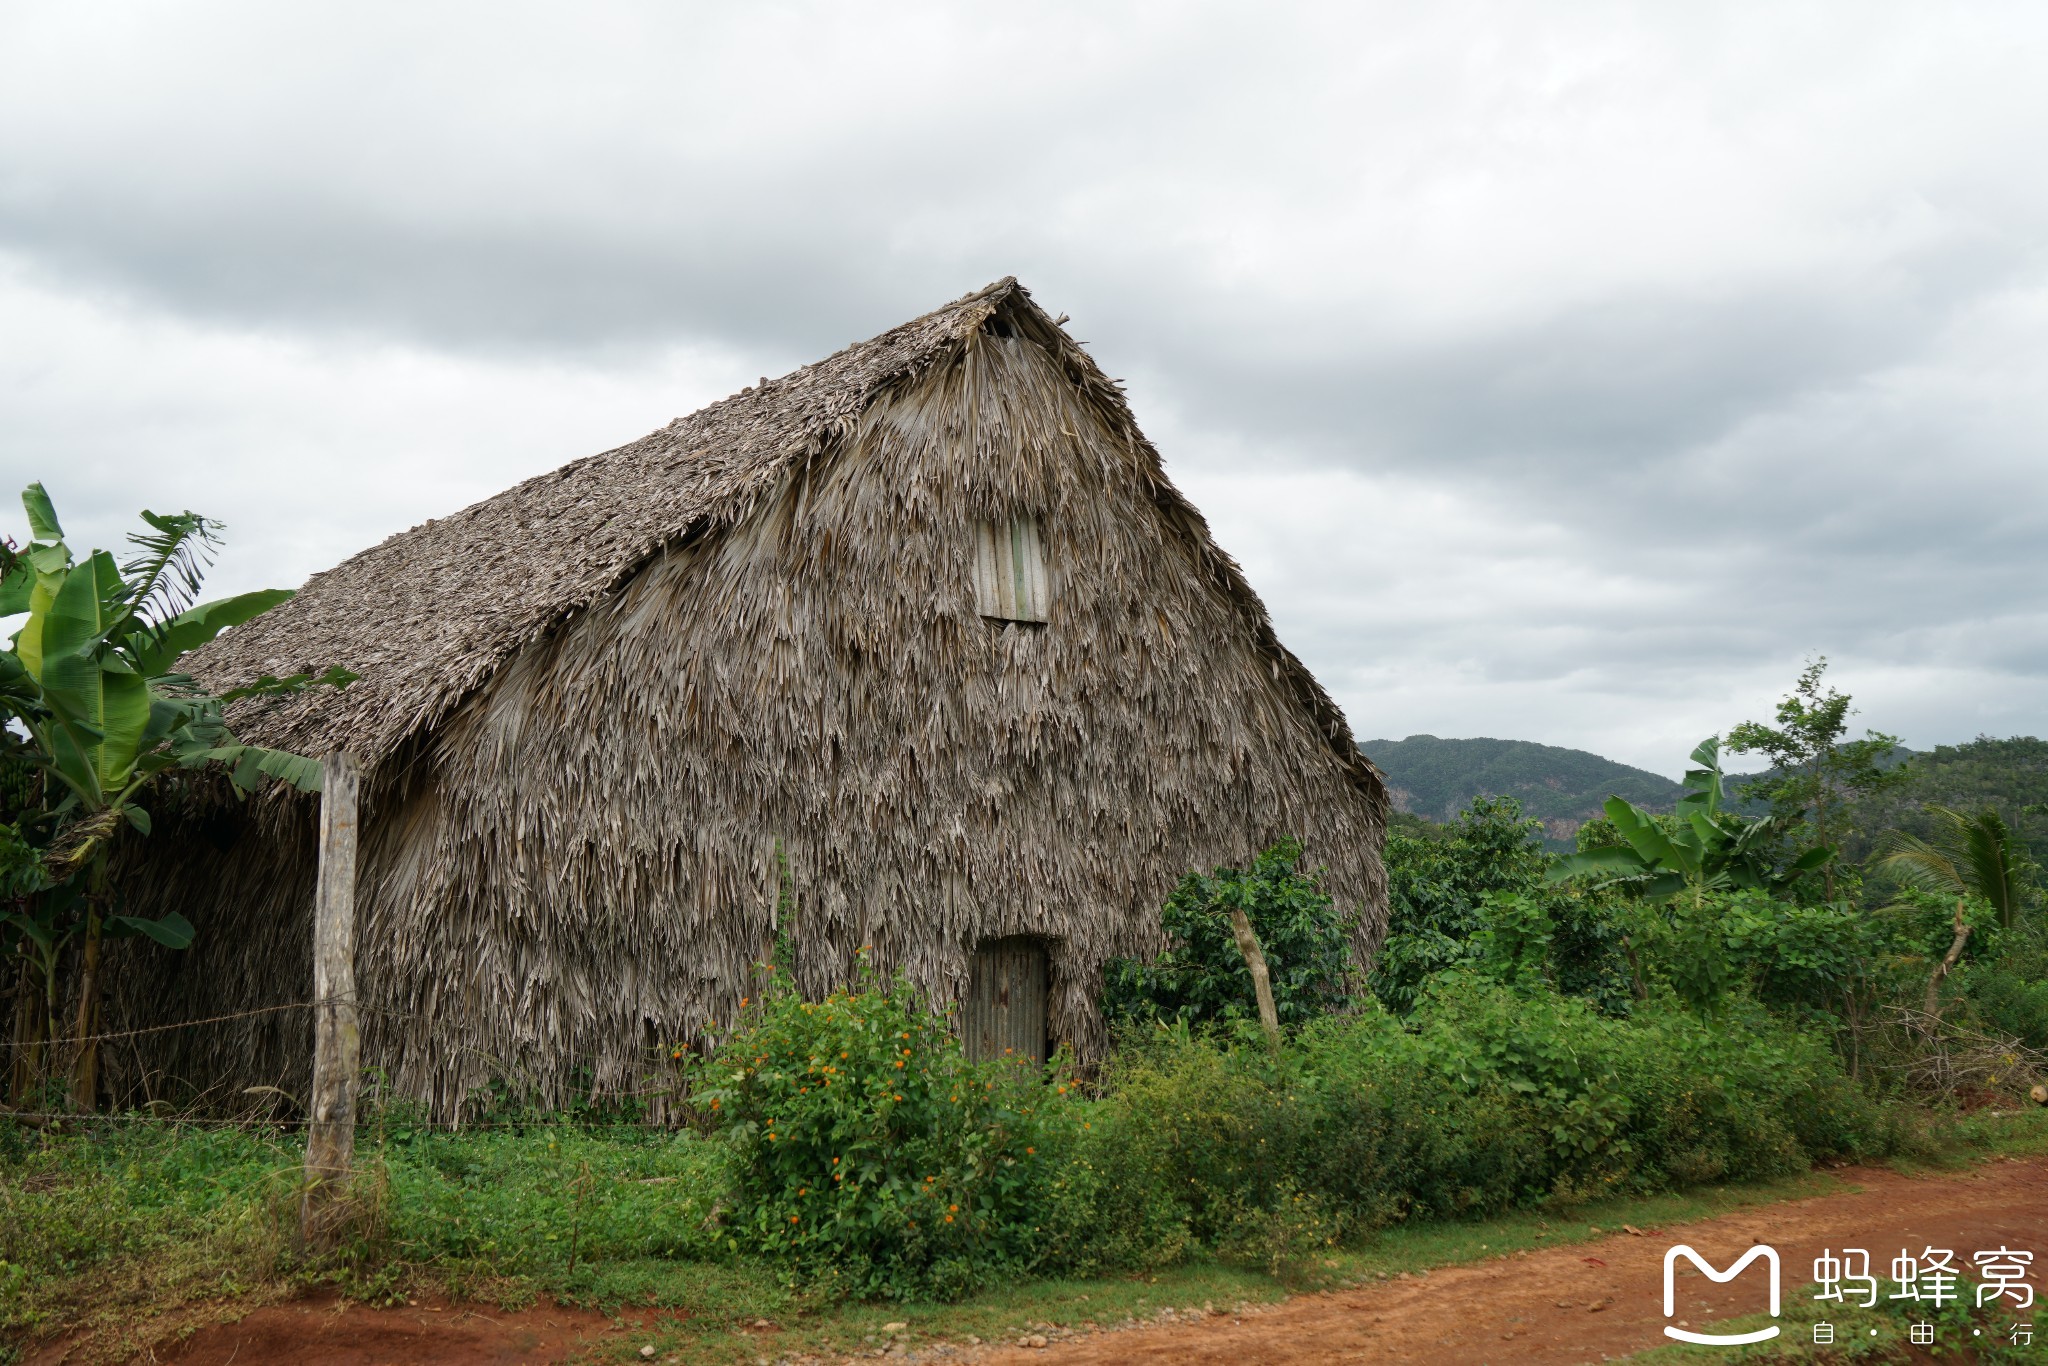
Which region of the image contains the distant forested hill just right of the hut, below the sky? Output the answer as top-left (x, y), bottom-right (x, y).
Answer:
top-left (1358, 735), bottom-right (1681, 844)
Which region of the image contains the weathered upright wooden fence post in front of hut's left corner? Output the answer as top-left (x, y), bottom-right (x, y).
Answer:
top-left (299, 754), bottom-right (362, 1251)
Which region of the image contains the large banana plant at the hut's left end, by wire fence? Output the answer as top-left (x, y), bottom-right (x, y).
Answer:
top-left (0, 483), bottom-right (354, 1108)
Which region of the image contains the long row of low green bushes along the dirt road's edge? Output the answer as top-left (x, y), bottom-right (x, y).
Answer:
top-left (1083, 973), bottom-right (1894, 1251)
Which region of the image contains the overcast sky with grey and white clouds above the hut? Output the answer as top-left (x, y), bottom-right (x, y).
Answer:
top-left (0, 0), bottom-right (2048, 774)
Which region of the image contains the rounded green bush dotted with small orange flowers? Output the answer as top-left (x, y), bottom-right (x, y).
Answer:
top-left (696, 979), bottom-right (1071, 1298)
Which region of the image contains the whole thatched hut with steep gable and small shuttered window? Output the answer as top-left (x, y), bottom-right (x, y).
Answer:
top-left (111, 281), bottom-right (1386, 1114)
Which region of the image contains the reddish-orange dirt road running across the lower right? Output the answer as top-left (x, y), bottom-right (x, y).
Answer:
top-left (981, 1159), bottom-right (2048, 1366)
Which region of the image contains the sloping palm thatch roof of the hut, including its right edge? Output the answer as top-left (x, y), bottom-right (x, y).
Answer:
top-left (186, 276), bottom-right (1386, 809)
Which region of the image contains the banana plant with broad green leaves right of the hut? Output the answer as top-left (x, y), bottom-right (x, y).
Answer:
top-left (1548, 735), bottom-right (1835, 901)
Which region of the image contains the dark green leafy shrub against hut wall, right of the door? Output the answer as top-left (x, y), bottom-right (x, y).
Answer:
top-left (1102, 840), bottom-right (1352, 1026)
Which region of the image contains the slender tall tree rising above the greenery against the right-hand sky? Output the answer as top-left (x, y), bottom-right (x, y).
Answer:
top-left (1729, 655), bottom-right (1907, 901)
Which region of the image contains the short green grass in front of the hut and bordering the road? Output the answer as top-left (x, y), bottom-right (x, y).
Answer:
top-left (0, 1112), bottom-right (2048, 1366)
